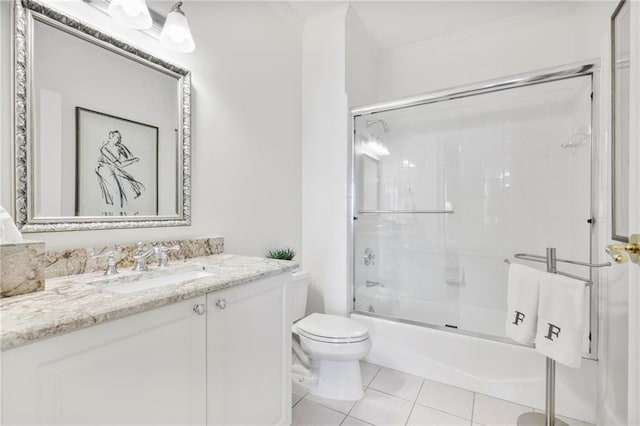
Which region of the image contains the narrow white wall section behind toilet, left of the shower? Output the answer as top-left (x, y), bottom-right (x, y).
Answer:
top-left (302, 6), bottom-right (348, 314)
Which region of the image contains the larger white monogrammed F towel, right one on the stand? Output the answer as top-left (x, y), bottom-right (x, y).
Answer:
top-left (536, 274), bottom-right (586, 368)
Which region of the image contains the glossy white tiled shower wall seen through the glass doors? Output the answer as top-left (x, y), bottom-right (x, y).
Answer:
top-left (355, 77), bottom-right (591, 336)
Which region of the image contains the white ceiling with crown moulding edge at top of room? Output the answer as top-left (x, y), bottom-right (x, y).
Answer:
top-left (288, 0), bottom-right (564, 49)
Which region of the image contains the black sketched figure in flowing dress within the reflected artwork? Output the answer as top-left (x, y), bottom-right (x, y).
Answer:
top-left (95, 130), bottom-right (145, 208)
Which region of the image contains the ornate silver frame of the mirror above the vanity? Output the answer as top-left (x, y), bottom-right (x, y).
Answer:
top-left (12, 0), bottom-right (191, 232)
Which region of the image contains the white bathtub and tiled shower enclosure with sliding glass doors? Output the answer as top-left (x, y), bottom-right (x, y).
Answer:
top-left (351, 64), bottom-right (598, 417)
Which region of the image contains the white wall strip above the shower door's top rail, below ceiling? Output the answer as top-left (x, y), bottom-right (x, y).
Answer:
top-left (378, 2), bottom-right (610, 101)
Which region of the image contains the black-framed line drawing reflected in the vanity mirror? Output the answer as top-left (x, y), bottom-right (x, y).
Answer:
top-left (75, 107), bottom-right (158, 216)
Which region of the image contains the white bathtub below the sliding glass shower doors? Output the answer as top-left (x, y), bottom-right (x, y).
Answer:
top-left (351, 289), bottom-right (597, 423)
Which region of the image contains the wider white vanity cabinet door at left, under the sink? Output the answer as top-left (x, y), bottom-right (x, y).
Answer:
top-left (2, 296), bottom-right (206, 425)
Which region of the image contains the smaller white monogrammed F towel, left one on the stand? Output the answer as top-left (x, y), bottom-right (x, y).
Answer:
top-left (505, 263), bottom-right (545, 345)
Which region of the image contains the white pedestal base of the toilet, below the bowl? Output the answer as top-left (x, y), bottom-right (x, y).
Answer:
top-left (309, 360), bottom-right (364, 401)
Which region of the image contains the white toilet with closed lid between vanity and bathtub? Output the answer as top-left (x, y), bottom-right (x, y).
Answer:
top-left (292, 271), bottom-right (371, 401)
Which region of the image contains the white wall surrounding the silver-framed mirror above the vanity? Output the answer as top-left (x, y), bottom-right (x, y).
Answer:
top-left (0, 1), bottom-right (301, 255)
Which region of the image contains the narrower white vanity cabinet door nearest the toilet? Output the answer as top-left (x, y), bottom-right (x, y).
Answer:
top-left (207, 274), bottom-right (291, 425)
